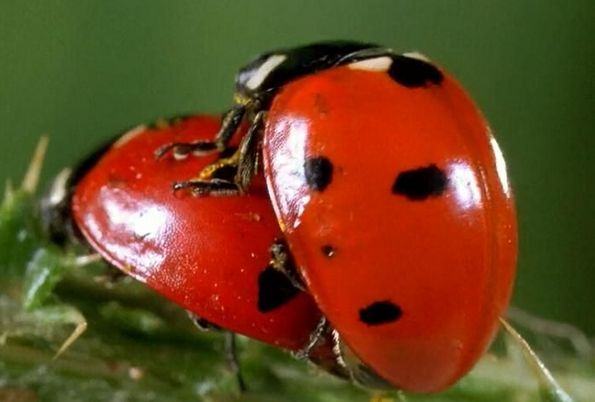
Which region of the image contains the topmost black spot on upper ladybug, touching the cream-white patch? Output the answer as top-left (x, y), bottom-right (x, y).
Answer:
top-left (387, 55), bottom-right (444, 88)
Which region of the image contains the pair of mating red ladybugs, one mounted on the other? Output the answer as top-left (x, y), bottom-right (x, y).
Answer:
top-left (45, 42), bottom-right (517, 392)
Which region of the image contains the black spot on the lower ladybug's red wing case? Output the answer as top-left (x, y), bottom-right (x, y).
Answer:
top-left (258, 266), bottom-right (299, 313)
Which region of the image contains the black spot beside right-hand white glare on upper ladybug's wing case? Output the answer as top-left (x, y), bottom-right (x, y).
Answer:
top-left (392, 165), bottom-right (448, 201)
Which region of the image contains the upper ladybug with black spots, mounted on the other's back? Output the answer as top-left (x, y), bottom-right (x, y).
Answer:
top-left (158, 42), bottom-right (517, 393)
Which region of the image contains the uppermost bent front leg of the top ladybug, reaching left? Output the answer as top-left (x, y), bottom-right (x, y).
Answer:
top-left (155, 103), bottom-right (246, 160)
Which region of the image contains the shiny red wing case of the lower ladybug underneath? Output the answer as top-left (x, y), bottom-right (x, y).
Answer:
top-left (72, 116), bottom-right (320, 350)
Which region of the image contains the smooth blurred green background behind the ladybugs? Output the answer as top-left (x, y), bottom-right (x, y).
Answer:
top-left (0, 0), bottom-right (595, 335)
